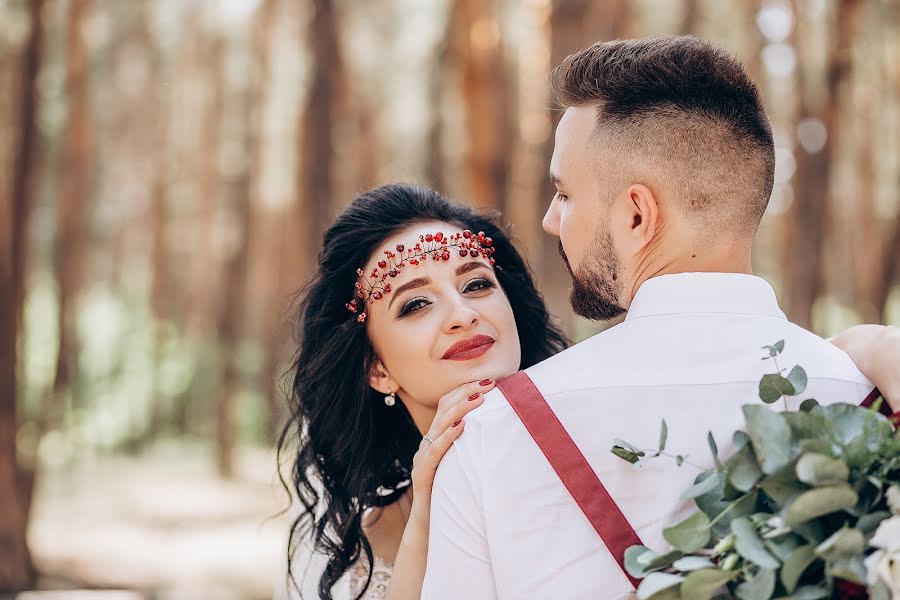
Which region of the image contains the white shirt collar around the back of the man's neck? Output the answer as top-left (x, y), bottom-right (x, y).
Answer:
top-left (625, 273), bottom-right (787, 321)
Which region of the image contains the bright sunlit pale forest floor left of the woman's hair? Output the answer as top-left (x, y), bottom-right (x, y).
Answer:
top-left (19, 442), bottom-right (288, 600)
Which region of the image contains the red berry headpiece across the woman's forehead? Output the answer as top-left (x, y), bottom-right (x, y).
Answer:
top-left (344, 229), bottom-right (495, 323)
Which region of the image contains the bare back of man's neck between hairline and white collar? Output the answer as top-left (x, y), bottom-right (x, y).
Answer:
top-left (629, 243), bottom-right (753, 304)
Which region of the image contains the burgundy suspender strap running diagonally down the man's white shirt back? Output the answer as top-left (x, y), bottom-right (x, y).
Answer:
top-left (497, 371), bottom-right (641, 588)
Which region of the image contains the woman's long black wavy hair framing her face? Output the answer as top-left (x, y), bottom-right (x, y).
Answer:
top-left (278, 184), bottom-right (567, 600)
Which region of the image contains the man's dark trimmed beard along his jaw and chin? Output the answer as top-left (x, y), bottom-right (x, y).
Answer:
top-left (559, 237), bottom-right (625, 321)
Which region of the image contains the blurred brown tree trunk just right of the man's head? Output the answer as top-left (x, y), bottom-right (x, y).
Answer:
top-left (783, 0), bottom-right (863, 329)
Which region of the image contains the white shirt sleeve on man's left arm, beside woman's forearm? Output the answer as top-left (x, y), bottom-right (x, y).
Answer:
top-left (422, 419), bottom-right (497, 600)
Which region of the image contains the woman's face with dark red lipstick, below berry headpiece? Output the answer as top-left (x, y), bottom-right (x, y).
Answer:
top-left (364, 222), bottom-right (521, 418)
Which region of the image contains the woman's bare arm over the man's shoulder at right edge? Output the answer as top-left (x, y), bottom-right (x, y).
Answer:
top-left (831, 325), bottom-right (900, 413)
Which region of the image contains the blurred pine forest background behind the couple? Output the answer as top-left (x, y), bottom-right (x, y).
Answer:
top-left (0, 0), bottom-right (900, 598)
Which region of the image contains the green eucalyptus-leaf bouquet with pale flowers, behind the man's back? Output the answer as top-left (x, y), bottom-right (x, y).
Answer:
top-left (612, 341), bottom-right (900, 600)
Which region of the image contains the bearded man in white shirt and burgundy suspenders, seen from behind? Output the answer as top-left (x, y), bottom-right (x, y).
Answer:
top-left (422, 37), bottom-right (871, 600)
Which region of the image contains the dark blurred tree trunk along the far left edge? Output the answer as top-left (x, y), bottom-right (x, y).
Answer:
top-left (0, 0), bottom-right (43, 593)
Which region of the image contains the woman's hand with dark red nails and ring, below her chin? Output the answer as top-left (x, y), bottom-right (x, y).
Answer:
top-left (410, 379), bottom-right (496, 532)
